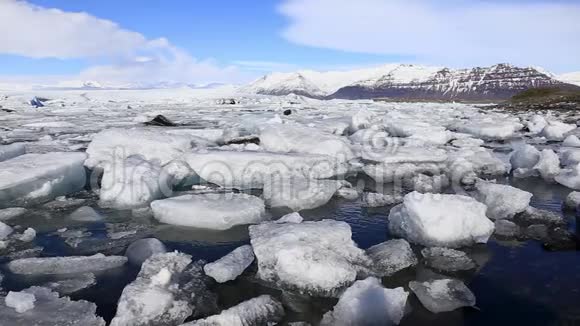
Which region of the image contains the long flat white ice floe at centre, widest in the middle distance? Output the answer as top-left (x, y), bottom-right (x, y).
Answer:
top-left (186, 150), bottom-right (348, 189)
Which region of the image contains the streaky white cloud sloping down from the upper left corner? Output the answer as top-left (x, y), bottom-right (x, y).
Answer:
top-left (0, 0), bottom-right (248, 84)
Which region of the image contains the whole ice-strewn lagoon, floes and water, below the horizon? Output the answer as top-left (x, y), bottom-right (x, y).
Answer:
top-left (0, 87), bottom-right (580, 326)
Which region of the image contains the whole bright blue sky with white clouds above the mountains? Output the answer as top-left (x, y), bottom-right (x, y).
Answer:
top-left (0, 0), bottom-right (580, 82)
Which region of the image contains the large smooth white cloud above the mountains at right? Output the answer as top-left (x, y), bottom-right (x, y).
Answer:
top-left (279, 0), bottom-right (580, 69)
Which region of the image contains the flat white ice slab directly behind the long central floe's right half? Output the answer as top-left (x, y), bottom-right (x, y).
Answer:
top-left (260, 124), bottom-right (354, 160)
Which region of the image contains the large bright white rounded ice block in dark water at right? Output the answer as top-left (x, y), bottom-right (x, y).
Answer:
top-left (389, 192), bottom-right (493, 247)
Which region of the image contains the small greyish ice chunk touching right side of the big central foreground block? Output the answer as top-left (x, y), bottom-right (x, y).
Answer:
top-left (367, 239), bottom-right (418, 276)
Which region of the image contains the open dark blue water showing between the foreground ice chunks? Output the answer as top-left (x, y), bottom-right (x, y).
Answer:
top-left (3, 178), bottom-right (580, 326)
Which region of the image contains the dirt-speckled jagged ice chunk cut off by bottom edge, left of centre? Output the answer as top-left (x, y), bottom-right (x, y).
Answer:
top-left (111, 252), bottom-right (208, 326)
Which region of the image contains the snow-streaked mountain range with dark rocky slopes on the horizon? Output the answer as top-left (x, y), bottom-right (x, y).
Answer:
top-left (242, 64), bottom-right (573, 100)
